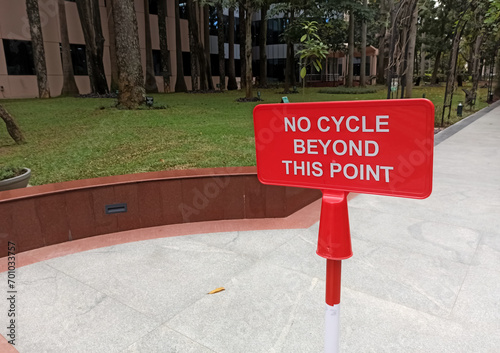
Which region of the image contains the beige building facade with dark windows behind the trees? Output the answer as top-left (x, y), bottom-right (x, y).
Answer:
top-left (0, 0), bottom-right (376, 99)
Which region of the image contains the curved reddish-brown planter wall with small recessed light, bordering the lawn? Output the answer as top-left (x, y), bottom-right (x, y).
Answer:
top-left (0, 167), bottom-right (321, 257)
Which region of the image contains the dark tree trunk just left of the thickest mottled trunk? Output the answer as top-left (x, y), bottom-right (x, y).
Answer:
top-left (76, 0), bottom-right (108, 94)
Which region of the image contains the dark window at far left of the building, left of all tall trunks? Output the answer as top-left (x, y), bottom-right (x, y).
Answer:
top-left (3, 39), bottom-right (36, 75)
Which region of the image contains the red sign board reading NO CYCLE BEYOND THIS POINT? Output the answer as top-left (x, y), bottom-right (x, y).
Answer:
top-left (254, 99), bottom-right (434, 198)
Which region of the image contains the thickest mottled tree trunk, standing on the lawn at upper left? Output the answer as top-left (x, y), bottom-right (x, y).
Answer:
top-left (112, 0), bottom-right (146, 109)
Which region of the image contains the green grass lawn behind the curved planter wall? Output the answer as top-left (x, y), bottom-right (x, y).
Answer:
top-left (0, 86), bottom-right (487, 185)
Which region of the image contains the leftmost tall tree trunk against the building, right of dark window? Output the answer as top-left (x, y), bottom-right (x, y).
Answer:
top-left (26, 0), bottom-right (50, 98)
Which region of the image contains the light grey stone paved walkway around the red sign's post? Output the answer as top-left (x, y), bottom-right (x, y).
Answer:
top-left (0, 101), bottom-right (500, 353)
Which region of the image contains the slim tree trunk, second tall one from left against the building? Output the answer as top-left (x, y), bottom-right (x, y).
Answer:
top-left (57, 0), bottom-right (78, 96)
